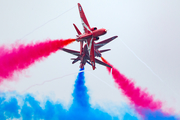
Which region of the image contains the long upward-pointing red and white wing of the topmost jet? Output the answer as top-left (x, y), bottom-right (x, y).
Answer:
top-left (78, 3), bottom-right (91, 33)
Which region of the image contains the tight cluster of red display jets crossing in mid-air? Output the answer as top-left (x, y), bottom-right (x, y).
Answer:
top-left (61, 3), bottom-right (118, 70)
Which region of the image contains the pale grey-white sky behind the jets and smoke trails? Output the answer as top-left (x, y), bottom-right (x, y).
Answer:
top-left (0, 0), bottom-right (180, 118)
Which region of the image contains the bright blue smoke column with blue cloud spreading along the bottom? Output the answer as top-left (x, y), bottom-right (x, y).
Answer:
top-left (0, 69), bottom-right (138, 120)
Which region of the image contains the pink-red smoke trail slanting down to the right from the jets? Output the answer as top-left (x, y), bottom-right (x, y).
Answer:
top-left (101, 57), bottom-right (162, 110)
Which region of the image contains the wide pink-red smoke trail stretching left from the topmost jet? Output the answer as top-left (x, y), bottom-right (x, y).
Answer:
top-left (0, 39), bottom-right (75, 83)
